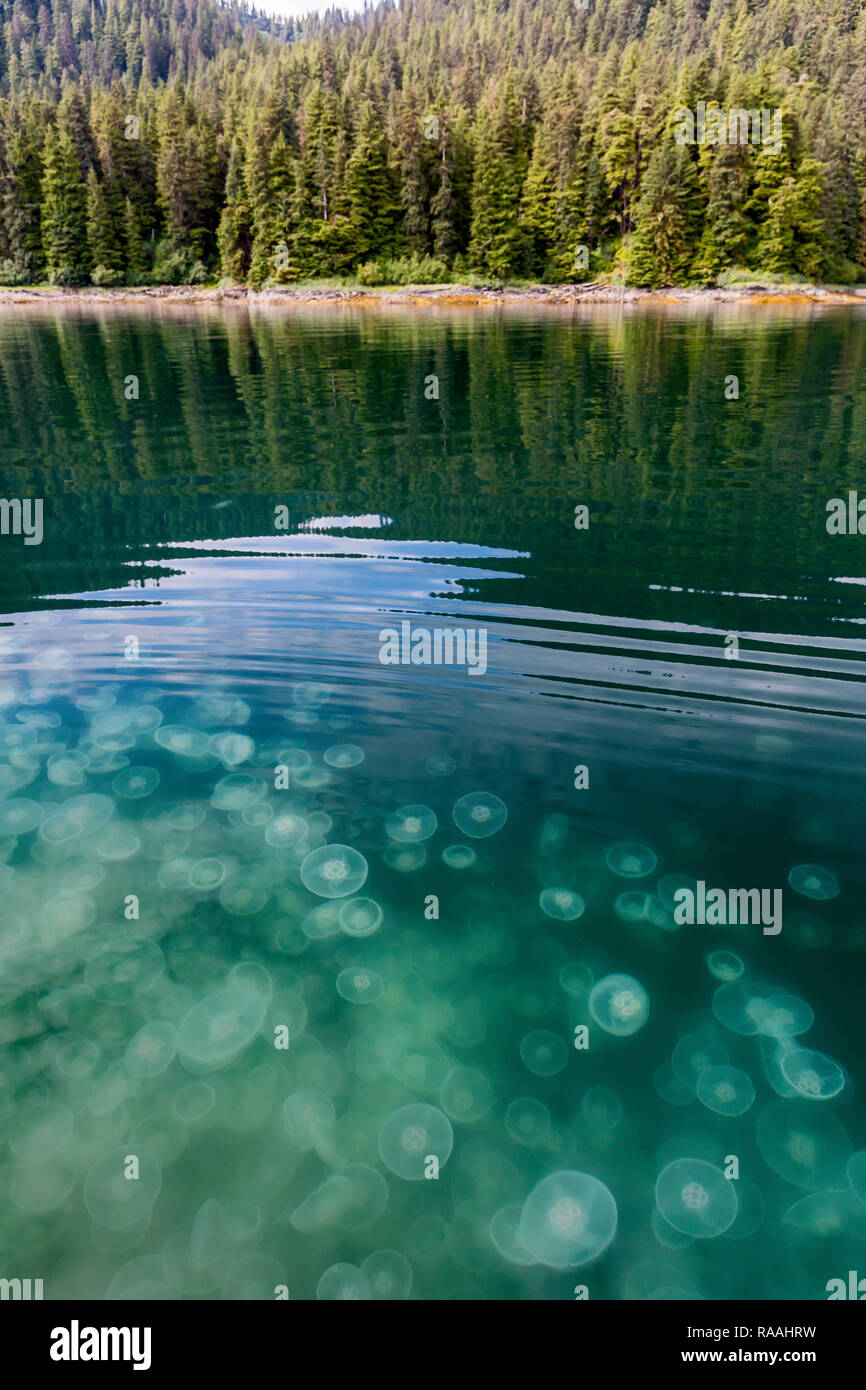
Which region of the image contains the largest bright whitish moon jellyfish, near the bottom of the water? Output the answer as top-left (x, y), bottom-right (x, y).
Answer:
top-left (517, 1170), bottom-right (617, 1269)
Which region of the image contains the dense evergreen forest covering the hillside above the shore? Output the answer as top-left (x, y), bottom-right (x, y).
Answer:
top-left (0, 0), bottom-right (866, 286)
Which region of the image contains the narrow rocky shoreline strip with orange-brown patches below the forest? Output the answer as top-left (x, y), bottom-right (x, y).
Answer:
top-left (0, 282), bottom-right (866, 309)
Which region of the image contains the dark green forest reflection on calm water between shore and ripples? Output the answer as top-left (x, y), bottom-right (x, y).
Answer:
top-left (0, 310), bottom-right (866, 621)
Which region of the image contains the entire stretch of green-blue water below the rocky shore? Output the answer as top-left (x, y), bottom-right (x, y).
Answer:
top-left (0, 309), bottom-right (866, 1300)
